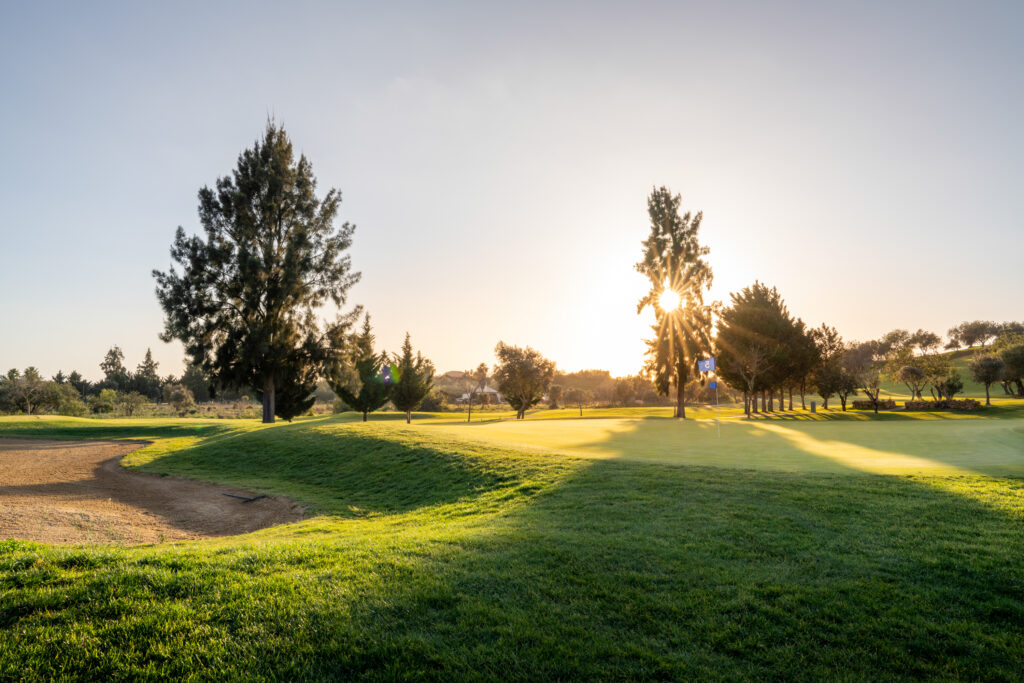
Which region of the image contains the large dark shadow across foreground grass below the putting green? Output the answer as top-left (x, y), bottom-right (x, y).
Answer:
top-left (278, 428), bottom-right (1024, 680)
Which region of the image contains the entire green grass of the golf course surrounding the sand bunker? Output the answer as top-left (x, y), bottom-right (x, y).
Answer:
top-left (0, 409), bottom-right (1024, 680)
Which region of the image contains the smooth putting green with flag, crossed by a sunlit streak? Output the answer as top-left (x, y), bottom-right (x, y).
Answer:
top-left (414, 415), bottom-right (1024, 476)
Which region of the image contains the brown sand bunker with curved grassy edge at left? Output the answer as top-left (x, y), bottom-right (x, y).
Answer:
top-left (0, 439), bottom-right (303, 544)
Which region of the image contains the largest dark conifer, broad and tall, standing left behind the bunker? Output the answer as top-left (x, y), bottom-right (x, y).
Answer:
top-left (154, 122), bottom-right (359, 423)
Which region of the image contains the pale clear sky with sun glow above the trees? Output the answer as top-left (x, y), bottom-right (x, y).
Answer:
top-left (0, 1), bottom-right (1024, 378)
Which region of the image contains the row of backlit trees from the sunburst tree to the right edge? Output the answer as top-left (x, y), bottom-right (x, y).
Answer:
top-left (636, 186), bottom-right (1024, 418)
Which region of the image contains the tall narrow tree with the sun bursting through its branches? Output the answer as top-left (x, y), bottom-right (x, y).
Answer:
top-left (636, 186), bottom-right (712, 419)
